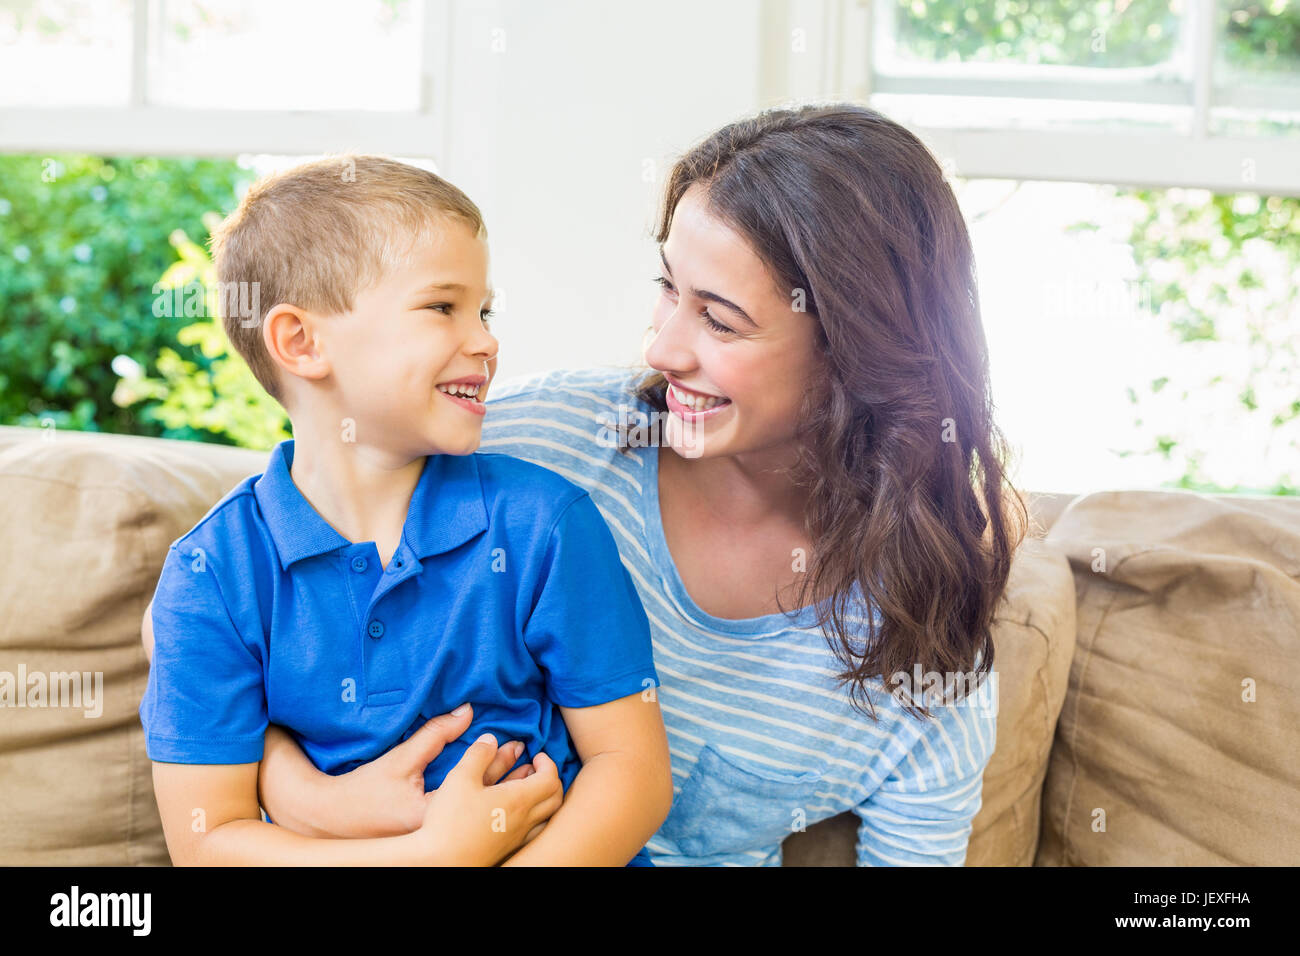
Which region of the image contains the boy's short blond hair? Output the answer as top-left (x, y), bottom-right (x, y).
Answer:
top-left (211, 153), bottom-right (486, 401)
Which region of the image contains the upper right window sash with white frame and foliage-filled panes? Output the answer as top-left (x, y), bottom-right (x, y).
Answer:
top-left (858, 0), bottom-right (1300, 194)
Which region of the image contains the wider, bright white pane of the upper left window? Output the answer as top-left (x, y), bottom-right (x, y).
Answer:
top-left (148, 0), bottom-right (421, 111)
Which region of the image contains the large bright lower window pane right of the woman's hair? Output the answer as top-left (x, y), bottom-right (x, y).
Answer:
top-left (972, 179), bottom-right (1300, 494)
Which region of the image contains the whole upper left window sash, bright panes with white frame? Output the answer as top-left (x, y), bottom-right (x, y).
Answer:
top-left (0, 0), bottom-right (450, 156)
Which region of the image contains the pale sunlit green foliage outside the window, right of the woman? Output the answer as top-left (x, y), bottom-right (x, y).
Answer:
top-left (1123, 190), bottom-right (1300, 494)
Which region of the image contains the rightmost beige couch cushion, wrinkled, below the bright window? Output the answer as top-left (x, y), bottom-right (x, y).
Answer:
top-left (1036, 492), bottom-right (1300, 866)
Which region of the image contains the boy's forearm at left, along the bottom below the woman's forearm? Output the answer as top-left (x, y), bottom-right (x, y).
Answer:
top-left (173, 819), bottom-right (439, 866)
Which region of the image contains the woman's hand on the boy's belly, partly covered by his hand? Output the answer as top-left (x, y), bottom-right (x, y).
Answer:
top-left (338, 704), bottom-right (549, 836)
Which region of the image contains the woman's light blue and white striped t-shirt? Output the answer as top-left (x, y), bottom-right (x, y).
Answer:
top-left (481, 367), bottom-right (997, 866)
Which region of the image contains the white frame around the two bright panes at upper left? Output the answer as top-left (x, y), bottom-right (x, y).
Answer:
top-left (0, 0), bottom-right (452, 159)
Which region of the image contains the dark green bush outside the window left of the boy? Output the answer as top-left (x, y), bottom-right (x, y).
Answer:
top-left (0, 155), bottom-right (250, 436)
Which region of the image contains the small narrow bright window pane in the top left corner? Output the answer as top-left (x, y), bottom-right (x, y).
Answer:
top-left (0, 0), bottom-right (131, 107)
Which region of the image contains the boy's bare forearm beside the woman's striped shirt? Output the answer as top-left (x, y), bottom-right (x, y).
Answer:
top-left (502, 752), bottom-right (672, 866)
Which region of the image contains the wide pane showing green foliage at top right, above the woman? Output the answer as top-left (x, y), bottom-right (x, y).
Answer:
top-left (876, 0), bottom-right (1187, 69)
